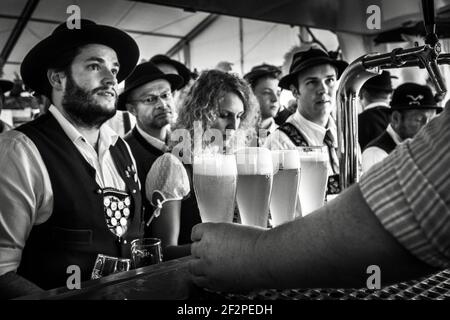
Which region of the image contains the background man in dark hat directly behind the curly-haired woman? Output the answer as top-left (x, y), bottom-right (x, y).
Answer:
top-left (244, 64), bottom-right (281, 145)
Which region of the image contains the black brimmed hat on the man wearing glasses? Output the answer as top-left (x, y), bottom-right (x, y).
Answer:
top-left (117, 61), bottom-right (183, 110)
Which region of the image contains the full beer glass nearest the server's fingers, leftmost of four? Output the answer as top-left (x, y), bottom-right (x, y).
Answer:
top-left (193, 153), bottom-right (237, 222)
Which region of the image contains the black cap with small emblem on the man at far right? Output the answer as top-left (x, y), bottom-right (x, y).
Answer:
top-left (390, 82), bottom-right (440, 111)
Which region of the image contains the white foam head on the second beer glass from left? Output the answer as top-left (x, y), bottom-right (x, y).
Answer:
top-left (236, 147), bottom-right (273, 175)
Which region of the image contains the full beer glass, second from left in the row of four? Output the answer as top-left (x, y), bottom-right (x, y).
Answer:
top-left (236, 147), bottom-right (273, 227)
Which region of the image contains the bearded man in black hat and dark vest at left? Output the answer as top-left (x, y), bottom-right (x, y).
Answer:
top-left (0, 20), bottom-right (142, 297)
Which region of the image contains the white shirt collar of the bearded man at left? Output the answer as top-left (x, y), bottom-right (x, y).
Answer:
top-left (48, 105), bottom-right (119, 149)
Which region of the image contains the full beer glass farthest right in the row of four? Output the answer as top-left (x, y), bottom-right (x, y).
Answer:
top-left (298, 147), bottom-right (328, 216)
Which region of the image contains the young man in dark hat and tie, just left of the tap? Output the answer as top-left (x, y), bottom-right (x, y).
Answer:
top-left (266, 48), bottom-right (347, 200)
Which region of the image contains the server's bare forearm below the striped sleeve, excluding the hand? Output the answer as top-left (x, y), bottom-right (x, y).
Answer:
top-left (256, 186), bottom-right (434, 287)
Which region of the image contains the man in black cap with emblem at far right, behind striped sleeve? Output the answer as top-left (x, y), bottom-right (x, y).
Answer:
top-left (362, 83), bottom-right (439, 173)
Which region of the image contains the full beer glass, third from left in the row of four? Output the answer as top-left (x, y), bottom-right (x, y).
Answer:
top-left (270, 150), bottom-right (300, 227)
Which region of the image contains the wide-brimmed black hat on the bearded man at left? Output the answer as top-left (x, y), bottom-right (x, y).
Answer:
top-left (20, 19), bottom-right (139, 94)
